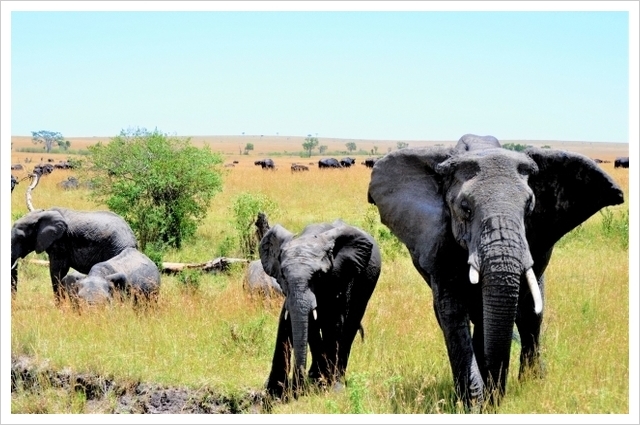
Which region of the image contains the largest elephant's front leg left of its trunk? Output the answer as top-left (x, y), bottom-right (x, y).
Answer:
top-left (432, 281), bottom-right (485, 408)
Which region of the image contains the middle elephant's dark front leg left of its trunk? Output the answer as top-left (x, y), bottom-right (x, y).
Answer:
top-left (266, 305), bottom-right (292, 398)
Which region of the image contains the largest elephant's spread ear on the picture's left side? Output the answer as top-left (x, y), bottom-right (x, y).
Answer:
top-left (368, 148), bottom-right (453, 273)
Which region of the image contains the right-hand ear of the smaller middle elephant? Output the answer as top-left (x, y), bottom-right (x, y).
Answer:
top-left (325, 222), bottom-right (373, 276)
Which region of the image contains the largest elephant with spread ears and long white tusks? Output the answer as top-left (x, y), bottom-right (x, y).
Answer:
top-left (368, 135), bottom-right (623, 407)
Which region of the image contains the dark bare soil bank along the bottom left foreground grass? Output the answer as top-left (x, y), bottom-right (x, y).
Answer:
top-left (11, 356), bottom-right (263, 414)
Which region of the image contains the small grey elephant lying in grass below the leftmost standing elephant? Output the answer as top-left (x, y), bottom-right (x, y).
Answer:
top-left (62, 248), bottom-right (160, 305)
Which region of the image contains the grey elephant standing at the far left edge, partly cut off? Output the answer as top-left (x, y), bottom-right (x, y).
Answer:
top-left (11, 208), bottom-right (138, 301)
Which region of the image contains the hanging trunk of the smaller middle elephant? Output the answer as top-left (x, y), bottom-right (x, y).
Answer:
top-left (286, 288), bottom-right (317, 396)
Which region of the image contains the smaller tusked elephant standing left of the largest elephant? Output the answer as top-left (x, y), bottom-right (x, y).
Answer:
top-left (260, 220), bottom-right (381, 398)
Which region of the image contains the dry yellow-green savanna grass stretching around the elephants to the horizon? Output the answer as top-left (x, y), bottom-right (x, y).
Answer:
top-left (8, 136), bottom-right (630, 414)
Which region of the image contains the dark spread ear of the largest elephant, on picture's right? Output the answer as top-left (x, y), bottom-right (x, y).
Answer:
top-left (525, 148), bottom-right (624, 251)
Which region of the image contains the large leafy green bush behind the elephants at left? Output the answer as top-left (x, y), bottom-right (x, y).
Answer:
top-left (88, 129), bottom-right (223, 251)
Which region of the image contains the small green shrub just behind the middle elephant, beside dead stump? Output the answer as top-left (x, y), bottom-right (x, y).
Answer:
top-left (231, 192), bottom-right (277, 258)
